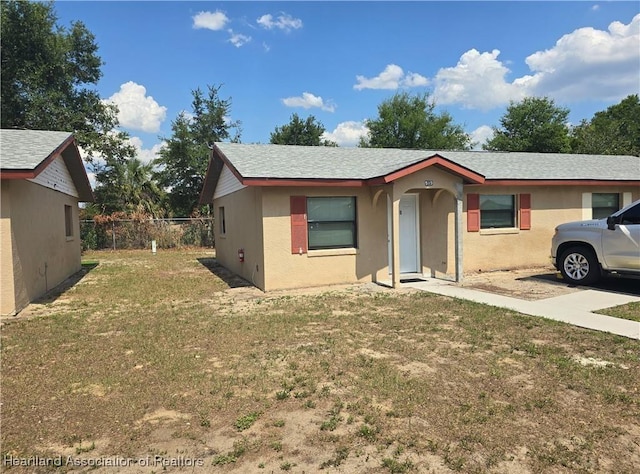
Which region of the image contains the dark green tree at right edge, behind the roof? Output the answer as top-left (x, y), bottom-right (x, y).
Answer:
top-left (571, 94), bottom-right (640, 156)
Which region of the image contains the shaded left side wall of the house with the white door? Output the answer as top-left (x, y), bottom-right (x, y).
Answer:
top-left (213, 187), bottom-right (265, 289)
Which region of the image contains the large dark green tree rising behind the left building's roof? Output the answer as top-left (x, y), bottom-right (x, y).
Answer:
top-left (0, 1), bottom-right (134, 161)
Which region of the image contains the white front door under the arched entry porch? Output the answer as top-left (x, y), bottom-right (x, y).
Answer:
top-left (387, 194), bottom-right (420, 273)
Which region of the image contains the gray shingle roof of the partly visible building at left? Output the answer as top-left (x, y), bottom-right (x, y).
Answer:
top-left (0, 129), bottom-right (71, 170)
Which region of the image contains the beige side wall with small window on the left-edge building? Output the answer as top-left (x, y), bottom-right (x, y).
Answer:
top-left (1, 180), bottom-right (82, 315)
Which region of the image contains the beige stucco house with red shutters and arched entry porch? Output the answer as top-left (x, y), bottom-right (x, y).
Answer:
top-left (200, 143), bottom-right (640, 291)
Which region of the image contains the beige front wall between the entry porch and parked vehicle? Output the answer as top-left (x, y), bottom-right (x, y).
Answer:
top-left (460, 186), bottom-right (640, 272)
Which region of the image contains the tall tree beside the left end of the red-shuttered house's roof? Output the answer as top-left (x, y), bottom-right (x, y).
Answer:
top-left (154, 86), bottom-right (241, 216)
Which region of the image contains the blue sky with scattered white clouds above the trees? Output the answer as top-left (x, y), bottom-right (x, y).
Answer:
top-left (55, 1), bottom-right (640, 161)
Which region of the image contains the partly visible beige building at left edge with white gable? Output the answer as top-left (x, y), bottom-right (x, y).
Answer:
top-left (0, 129), bottom-right (93, 315)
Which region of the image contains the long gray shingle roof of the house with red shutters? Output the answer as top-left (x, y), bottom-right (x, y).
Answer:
top-left (215, 143), bottom-right (640, 180)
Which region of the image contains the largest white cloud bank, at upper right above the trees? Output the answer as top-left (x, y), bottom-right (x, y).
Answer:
top-left (434, 14), bottom-right (640, 110)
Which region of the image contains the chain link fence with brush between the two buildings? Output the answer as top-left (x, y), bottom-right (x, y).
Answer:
top-left (80, 218), bottom-right (215, 250)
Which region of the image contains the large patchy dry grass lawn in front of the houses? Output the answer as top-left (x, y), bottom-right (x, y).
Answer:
top-left (1, 251), bottom-right (640, 473)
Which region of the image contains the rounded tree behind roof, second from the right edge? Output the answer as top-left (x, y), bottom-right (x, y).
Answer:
top-left (482, 97), bottom-right (570, 153)
